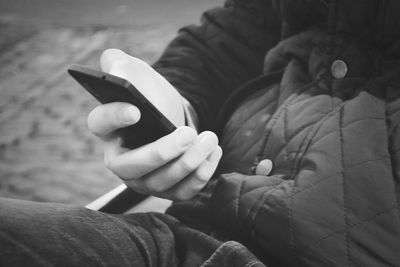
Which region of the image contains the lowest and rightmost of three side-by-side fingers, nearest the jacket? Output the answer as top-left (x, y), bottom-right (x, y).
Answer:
top-left (161, 146), bottom-right (222, 200)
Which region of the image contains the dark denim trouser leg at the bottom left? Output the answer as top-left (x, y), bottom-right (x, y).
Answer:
top-left (0, 198), bottom-right (264, 267)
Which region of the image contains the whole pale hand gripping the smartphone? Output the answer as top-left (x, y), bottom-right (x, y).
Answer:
top-left (88, 50), bottom-right (222, 200)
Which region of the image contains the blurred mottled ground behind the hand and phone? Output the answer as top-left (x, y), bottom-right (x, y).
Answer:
top-left (0, 0), bottom-right (223, 205)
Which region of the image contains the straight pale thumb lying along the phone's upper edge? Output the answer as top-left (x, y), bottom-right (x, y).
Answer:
top-left (100, 49), bottom-right (184, 126)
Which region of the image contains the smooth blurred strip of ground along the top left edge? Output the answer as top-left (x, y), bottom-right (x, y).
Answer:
top-left (0, 0), bottom-right (224, 27)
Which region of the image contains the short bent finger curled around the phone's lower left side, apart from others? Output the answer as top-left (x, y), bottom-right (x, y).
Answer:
top-left (87, 102), bottom-right (140, 138)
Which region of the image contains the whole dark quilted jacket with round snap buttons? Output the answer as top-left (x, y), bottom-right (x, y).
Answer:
top-left (155, 0), bottom-right (400, 266)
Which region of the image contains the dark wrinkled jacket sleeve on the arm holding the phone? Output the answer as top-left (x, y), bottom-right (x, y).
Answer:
top-left (154, 0), bottom-right (280, 130)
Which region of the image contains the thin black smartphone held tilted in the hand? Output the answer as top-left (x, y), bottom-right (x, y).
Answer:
top-left (68, 65), bottom-right (176, 149)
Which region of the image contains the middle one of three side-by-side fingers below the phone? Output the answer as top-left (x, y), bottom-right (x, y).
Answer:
top-left (133, 131), bottom-right (218, 193)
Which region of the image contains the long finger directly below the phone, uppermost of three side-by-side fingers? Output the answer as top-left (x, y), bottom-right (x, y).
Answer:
top-left (110, 126), bottom-right (197, 180)
